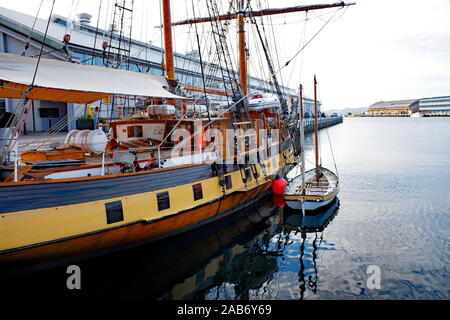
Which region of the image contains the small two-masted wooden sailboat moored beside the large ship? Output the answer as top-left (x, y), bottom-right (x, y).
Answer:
top-left (284, 76), bottom-right (339, 212)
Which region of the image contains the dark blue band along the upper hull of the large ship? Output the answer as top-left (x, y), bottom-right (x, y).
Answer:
top-left (0, 164), bottom-right (213, 213)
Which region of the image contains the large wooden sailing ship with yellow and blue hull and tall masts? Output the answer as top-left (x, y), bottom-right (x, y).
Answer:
top-left (0, 0), bottom-right (354, 265)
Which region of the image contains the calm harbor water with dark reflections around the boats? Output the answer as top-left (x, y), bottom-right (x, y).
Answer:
top-left (0, 118), bottom-right (450, 300)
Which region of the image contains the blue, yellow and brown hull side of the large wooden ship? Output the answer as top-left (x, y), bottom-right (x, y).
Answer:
top-left (0, 144), bottom-right (293, 266)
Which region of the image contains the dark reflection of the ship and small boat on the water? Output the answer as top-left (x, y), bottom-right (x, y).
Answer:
top-left (1, 197), bottom-right (339, 300)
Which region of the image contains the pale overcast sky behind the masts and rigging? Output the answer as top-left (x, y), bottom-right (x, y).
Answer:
top-left (0, 0), bottom-right (450, 110)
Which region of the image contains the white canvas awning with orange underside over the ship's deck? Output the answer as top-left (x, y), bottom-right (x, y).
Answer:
top-left (0, 53), bottom-right (186, 102)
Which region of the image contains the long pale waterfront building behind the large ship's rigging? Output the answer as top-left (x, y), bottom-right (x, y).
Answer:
top-left (0, 7), bottom-right (321, 131)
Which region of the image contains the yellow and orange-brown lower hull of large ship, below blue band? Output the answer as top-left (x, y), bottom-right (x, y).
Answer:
top-left (0, 148), bottom-right (293, 264)
